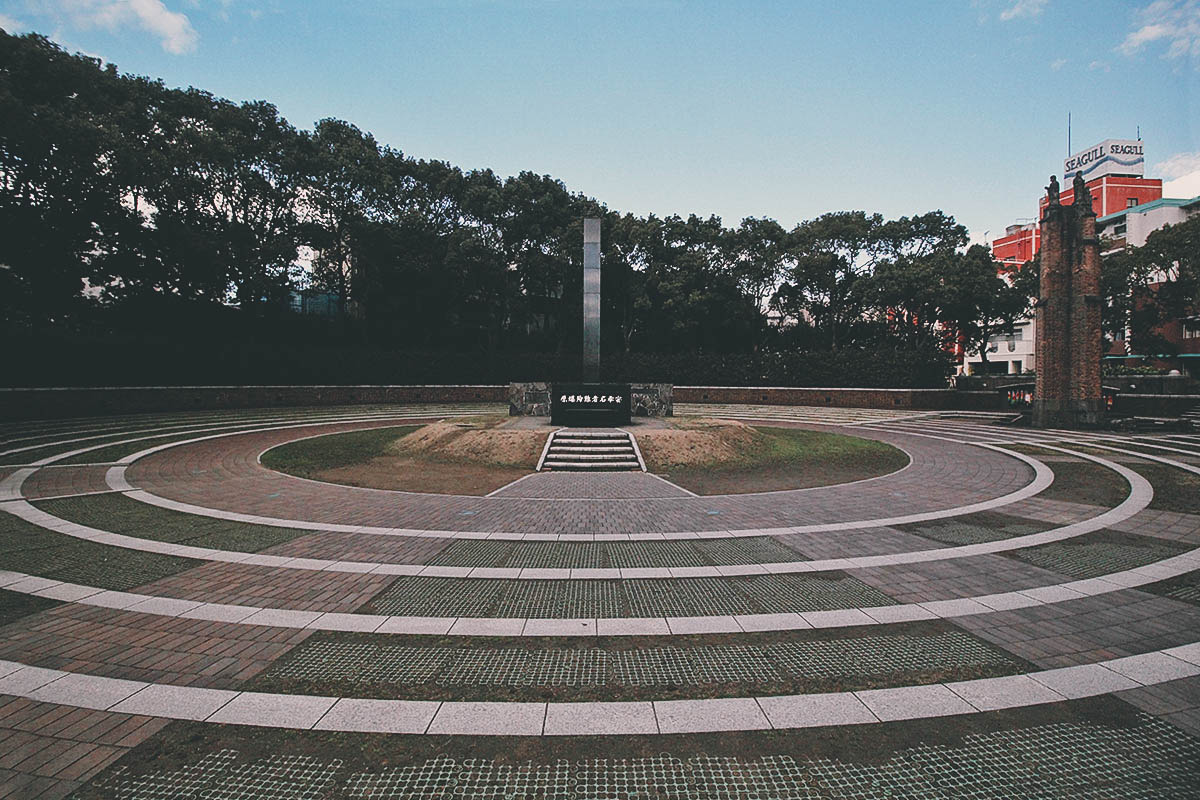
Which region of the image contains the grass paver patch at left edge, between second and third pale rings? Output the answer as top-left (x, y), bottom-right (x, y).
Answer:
top-left (0, 513), bottom-right (204, 590)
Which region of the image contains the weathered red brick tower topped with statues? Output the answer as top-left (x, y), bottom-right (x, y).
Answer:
top-left (1033, 173), bottom-right (1104, 428)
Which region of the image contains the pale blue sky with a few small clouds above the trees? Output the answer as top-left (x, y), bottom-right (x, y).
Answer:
top-left (0, 0), bottom-right (1200, 244)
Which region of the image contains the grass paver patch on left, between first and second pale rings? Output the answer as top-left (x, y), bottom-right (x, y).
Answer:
top-left (34, 492), bottom-right (314, 553)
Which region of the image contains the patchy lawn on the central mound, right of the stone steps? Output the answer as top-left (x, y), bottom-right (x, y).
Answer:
top-left (646, 426), bottom-right (908, 494)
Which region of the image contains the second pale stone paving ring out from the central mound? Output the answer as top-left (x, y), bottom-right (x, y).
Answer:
top-left (0, 446), bottom-right (1142, 581)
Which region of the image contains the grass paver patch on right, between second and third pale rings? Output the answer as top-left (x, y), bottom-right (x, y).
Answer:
top-left (1002, 530), bottom-right (1192, 578)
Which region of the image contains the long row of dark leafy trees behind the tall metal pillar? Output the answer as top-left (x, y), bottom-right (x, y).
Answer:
top-left (0, 31), bottom-right (1027, 381)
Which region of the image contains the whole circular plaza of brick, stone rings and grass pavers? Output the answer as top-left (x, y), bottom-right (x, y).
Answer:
top-left (0, 405), bottom-right (1200, 800)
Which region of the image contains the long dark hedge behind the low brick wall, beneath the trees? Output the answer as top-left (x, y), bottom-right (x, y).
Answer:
top-left (0, 335), bottom-right (950, 389)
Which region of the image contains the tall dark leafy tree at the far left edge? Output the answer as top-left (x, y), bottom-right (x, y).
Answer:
top-left (0, 31), bottom-right (138, 323)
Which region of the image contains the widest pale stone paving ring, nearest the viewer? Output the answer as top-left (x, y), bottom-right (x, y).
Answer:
top-left (0, 643), bottom-right (1200, 736)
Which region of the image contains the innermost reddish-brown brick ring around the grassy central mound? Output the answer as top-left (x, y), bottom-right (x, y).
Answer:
top-left (127, 425), bottom-right (1031, 534)
